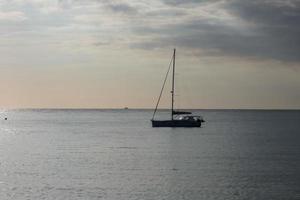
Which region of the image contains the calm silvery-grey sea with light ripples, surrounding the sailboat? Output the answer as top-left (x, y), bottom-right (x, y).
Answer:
top-left (0, 110), bottom-right (300, 200)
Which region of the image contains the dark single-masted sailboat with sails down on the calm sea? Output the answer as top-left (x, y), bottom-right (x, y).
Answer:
top-left (151, 49), bottom-right (204, 127)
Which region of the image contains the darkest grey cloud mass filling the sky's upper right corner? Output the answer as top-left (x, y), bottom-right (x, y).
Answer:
top-left (227, 1), bottom-right (300, 61)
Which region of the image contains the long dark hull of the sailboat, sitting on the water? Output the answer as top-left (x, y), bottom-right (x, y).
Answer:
top-left (151, 120), bottom-right (201, 127)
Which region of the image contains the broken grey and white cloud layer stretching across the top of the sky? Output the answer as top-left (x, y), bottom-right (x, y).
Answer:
top-left (0, 0), bottom-right (300, 62)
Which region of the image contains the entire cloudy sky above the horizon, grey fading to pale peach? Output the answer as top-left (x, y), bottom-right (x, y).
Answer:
top-left (0, 0), bottom-right (300, 109)
